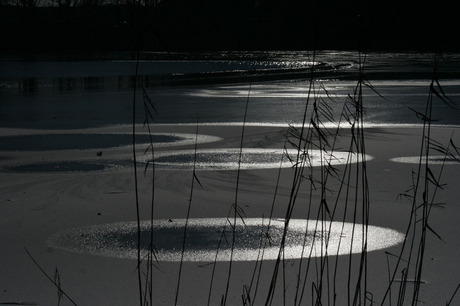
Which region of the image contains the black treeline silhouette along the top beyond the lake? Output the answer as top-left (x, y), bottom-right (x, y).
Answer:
top-left (0, 0), bottom-right (460, 52)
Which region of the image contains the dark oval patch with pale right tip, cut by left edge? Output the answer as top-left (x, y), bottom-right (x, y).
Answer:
top-left (0, 133), bottom-right (221, 151)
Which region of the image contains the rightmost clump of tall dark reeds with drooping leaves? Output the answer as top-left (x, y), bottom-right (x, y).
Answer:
top-left (382, 54), bottom-right (456, 305)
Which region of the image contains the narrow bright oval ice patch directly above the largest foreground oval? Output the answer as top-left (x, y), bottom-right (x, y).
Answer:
top-left (147, 148), bottom-right (372, 170)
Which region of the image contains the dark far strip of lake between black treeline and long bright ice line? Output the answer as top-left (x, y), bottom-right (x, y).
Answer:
top-left (0, 51), bottom-right (460, 129)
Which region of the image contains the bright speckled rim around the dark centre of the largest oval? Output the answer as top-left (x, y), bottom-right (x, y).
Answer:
top-left (47, 218), bottom-right (404, 262)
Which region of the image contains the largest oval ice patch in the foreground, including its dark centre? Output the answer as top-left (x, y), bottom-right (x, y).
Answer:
top-left (48, 218), bottom-right (404, 262)
